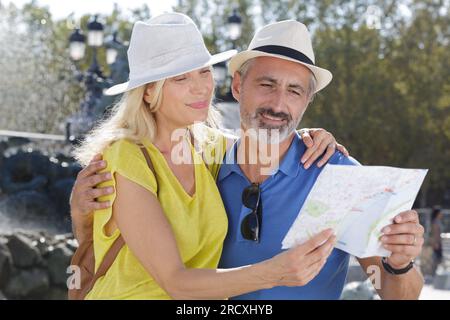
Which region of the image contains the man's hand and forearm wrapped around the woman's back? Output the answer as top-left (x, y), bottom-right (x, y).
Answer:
top-left (70, 155), bottom-right (114, 243)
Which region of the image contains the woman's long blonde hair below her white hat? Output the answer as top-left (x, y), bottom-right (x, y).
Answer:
top-left (73, 73), bottom-right (220, 166)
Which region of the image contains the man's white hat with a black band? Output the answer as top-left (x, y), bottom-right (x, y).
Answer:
top-left (228, 20), bottom-right (333, 92)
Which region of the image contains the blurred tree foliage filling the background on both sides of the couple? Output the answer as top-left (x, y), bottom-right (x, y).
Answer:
top-left (0, 0), bottom-right (450, 203)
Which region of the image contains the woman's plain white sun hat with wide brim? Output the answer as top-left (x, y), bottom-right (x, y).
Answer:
top-left (105, 13), bottom-right (237, 95)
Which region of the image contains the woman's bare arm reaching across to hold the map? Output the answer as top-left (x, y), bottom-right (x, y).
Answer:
top-left (112, 173), bottom-right (335, 299)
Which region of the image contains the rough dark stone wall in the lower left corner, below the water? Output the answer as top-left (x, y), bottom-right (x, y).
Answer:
top-left (0, 231), bottom-right (77, 300)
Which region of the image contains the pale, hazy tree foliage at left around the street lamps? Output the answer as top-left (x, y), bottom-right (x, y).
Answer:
top-left (0, 1), bottom-right (150, 134)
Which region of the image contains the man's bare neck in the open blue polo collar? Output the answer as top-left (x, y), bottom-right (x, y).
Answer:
top-left (237, 132), bottom-right (300, 183)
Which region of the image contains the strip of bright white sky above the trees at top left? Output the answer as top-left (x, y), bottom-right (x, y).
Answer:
top-left (0, 0), bottom-right (177, 20)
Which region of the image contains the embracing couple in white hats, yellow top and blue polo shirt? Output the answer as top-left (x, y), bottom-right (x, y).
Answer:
top-left (71, 13), bottom-right (423, 299)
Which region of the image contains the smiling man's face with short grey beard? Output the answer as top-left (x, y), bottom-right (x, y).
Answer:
top-left (233, 57), bottom-right (311, 143)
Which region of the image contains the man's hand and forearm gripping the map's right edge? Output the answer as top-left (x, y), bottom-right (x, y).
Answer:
top-left (358, 210), bottom-right (424, 300)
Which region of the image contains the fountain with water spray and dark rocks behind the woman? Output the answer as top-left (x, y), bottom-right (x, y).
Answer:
top-left (0, 6), bottom-right (128, 300)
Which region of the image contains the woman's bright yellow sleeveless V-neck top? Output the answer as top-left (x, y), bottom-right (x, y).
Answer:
top-left (86, 129), bottom-right (228, 300)
